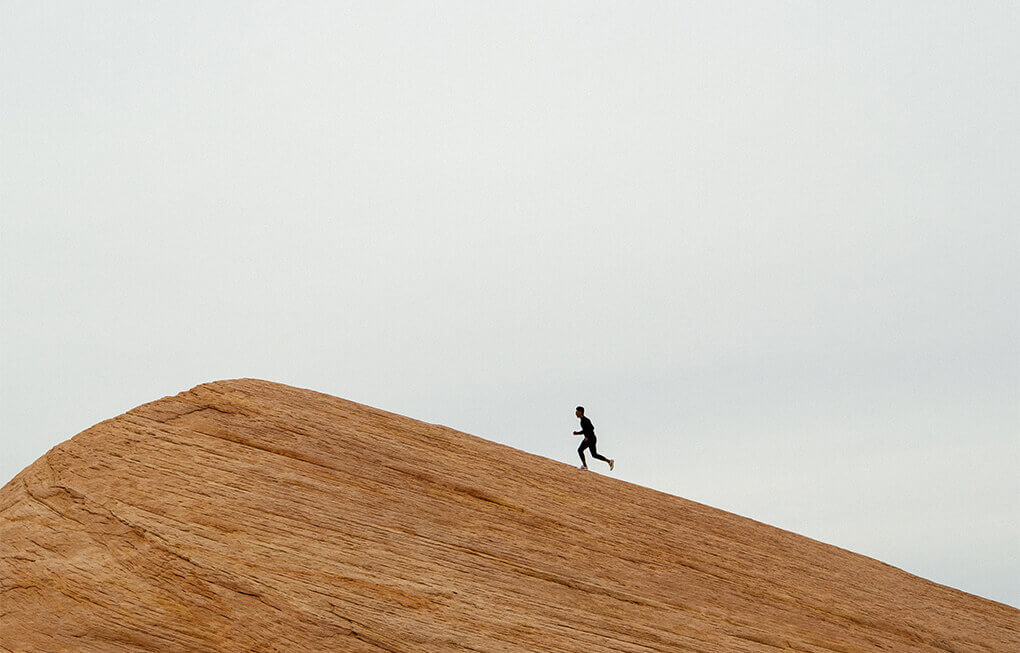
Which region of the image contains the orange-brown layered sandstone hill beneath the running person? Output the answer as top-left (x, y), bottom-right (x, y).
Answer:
top-left (0, 379), bottom-right (1020, 652)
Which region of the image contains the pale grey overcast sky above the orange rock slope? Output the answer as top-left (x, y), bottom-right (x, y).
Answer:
top-left (0, 0), bottom-right (1020, 605)
